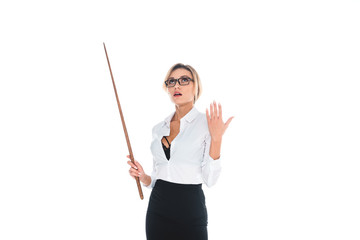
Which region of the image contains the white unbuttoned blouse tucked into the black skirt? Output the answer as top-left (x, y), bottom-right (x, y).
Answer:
top-left (143, 106), bottom-right (221, 188)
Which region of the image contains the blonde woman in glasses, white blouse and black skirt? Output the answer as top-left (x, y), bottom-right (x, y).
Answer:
top-left (127, 63), bottom-right (233, 240)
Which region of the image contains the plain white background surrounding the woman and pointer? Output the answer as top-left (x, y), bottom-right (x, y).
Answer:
top-left (0, 0), bottom-right (360, 240)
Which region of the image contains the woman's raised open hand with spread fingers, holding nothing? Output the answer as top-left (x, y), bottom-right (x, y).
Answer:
top-left (206, 101), bottom-right (234, 141)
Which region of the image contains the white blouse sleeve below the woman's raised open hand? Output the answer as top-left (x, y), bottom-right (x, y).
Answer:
top-left (201, 133), bottom-right (221, 187)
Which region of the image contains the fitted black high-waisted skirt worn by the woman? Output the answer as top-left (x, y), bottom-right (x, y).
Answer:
top-left (146, 179), bottom-right (208, 240)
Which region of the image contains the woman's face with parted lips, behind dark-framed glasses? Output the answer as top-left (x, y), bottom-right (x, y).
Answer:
top-left (167, 68), bottom-right (194, 105)
